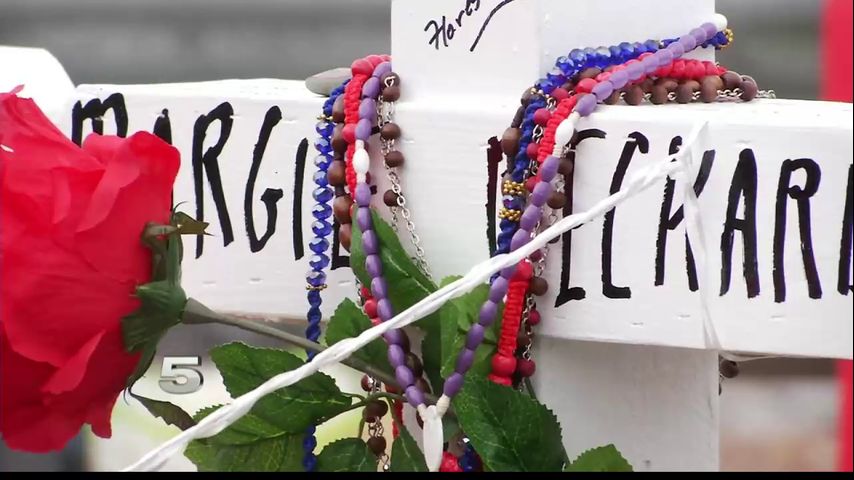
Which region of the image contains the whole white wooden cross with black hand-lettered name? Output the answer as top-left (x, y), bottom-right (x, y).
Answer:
top-left (0, 0), bottom-right (854, 470)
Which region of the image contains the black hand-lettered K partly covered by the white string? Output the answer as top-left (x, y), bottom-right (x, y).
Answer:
top-left (655, 137), bottom-right (715, 292)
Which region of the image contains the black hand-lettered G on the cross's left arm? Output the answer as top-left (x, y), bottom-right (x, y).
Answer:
top-left (243, 107), bottom-right (286, 253)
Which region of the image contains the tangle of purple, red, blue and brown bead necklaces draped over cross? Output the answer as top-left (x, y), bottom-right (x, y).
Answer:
top-left (306, 15), bottom-right (767, 468)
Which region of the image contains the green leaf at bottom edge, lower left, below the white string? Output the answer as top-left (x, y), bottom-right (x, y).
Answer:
top-left (184, 407), bottom-right (304, 472)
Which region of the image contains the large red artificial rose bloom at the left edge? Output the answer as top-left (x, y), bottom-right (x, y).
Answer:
top-left (0, 94), bottom-right (180, 452)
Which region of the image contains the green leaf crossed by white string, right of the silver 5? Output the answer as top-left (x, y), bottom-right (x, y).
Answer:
top-left (211, 343), bottom-right (352, 433)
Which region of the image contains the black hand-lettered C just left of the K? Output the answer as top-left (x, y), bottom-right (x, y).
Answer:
top-left (602, 132), bottom-right (649, 299)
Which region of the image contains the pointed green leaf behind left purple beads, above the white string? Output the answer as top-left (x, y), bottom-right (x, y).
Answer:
top-left (350, 211), bottom-right (439, 329)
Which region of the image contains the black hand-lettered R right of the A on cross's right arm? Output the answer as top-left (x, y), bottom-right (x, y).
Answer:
top-left (774, 158), bottom-right (821, 303)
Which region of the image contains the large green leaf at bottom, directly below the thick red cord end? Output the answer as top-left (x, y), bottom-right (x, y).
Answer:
top-left (453, 375), bottom-right (566, 472)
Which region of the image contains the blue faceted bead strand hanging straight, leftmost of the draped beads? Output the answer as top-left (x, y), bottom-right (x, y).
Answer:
top-left (302, 80), bottom-right (349, 472)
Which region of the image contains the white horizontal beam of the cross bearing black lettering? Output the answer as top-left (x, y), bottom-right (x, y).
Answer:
top-left (60, 80), bottom-right (854, 358)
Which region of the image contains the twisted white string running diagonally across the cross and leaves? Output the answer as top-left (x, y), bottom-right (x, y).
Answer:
top-left (125, 122), bottom-right (714, 471)
